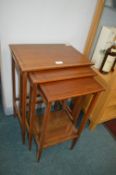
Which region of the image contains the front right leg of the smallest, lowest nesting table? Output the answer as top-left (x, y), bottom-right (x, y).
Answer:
top-left (71, 93), bottom-right (100, 149)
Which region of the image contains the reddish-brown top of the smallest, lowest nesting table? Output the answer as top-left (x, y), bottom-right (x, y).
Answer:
top-left (39, 77), bottom-right (104, 102)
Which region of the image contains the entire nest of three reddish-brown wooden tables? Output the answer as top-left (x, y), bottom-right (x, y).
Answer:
top-left (10, 44), bottom-right (103, 159)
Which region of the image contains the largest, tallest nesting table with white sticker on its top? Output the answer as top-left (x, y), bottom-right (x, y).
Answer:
top-left (10, 44), bottom-right (95, 143)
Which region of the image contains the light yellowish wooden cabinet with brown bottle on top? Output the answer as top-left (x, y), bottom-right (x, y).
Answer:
top-left (83, 68), bottom-right (116, 129)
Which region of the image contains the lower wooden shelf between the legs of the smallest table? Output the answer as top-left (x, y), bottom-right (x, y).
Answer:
top-left (33, 111), bottom-right (77, 148)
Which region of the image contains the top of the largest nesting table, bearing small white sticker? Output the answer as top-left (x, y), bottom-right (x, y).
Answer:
top-left (10, 44), bottom-right (91, 71)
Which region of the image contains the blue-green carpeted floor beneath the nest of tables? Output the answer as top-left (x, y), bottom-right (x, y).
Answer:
top-left (0, 98), bottom-right (116, 175)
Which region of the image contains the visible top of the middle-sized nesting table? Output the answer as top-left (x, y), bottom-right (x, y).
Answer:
top-left (30, 66), bottom-right (96, 83)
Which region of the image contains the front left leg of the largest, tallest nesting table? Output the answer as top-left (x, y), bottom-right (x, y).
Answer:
top-left (20, 72), bottom-right (27, 144)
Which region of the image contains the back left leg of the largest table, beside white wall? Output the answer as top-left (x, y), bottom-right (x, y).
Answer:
top-left (12, 57), bottom-right (16, 116)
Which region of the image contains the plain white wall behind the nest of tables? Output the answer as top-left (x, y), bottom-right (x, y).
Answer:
top-left (0, 0), bottom-right (97, 114)
